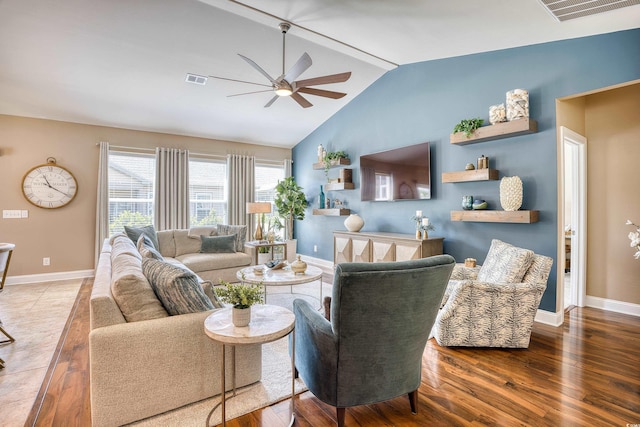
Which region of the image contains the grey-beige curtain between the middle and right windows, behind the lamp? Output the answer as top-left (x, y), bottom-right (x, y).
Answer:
top-left (227, 154), bottom-right (256, 240)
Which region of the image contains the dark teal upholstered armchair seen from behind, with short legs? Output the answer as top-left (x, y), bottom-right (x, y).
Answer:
top-left (293, 255), bottom-right (455, 426)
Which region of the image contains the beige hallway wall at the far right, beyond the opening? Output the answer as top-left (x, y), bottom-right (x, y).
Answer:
top-left (585, 84), bottom-right (640, 304)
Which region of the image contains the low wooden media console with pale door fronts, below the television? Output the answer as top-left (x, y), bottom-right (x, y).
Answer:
top-left (333, 231), bottom-right (444, 264)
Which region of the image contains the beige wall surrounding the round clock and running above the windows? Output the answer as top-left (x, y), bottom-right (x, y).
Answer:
top-left (0, 115), bottom-right (291, 276)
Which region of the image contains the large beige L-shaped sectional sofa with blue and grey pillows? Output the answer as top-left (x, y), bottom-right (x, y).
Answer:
top-left (89, 230), bottom-right (262, 426)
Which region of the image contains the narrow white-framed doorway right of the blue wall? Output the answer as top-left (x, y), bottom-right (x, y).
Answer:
top-left (557, 126), bottom-right (587, 310)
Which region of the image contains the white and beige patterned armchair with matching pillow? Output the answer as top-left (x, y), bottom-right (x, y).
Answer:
top-left (432, 239), bottom-right (553, 348)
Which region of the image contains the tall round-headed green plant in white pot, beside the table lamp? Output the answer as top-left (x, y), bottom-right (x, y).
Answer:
top-left (274, 176), bottom-right (307, 261)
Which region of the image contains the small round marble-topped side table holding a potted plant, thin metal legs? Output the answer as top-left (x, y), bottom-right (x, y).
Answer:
top-left (204, 305), bottom-right (296, 427)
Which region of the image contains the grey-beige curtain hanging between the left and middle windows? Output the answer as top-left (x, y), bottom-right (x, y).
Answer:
top-left (153, 147), bottom-right (189, 230)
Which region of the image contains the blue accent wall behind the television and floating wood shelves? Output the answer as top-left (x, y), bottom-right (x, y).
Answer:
top-left (293, 29), bottom-right (640, 312)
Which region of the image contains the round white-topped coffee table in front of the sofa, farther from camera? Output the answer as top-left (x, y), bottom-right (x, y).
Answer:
top-left (236, 266), bottom-right (322, 308)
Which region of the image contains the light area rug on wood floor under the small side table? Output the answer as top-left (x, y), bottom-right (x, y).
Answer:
top-left (128, 337), bottom-right (307, 427)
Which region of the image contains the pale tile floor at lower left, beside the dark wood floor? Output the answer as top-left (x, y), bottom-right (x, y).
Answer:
top-left (0, 279), bottom-right (82, 427)
